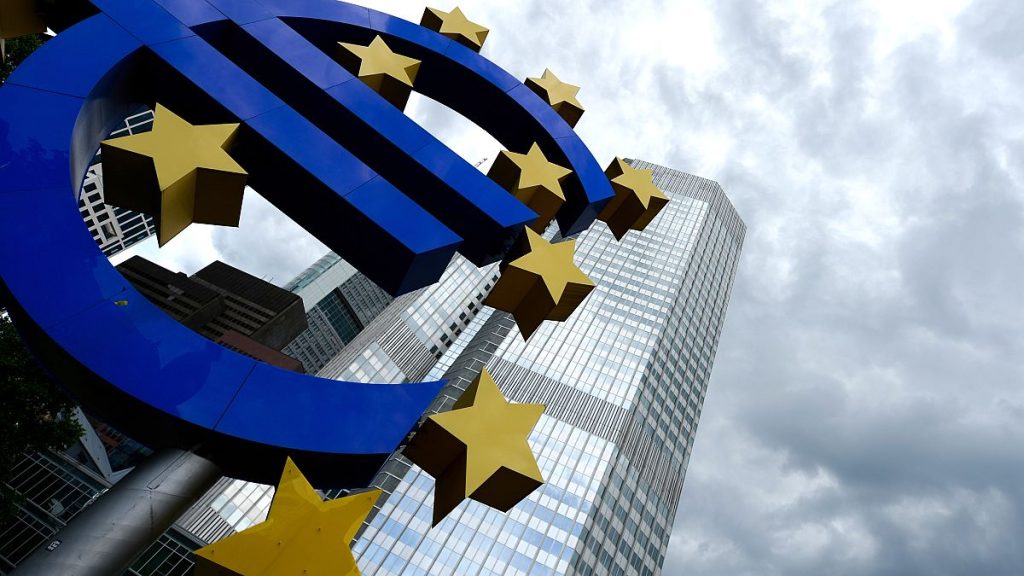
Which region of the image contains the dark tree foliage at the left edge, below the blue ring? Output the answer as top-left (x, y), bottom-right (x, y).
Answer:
top-left (0, 311), bottom-right (83, 521)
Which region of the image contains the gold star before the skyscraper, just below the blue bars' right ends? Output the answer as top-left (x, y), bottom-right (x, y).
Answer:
top-left (483, 229), bottom-right (594, 338)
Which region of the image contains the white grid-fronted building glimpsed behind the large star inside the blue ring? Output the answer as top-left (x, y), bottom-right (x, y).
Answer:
top-left (78, 110), bottom-right (157, 257)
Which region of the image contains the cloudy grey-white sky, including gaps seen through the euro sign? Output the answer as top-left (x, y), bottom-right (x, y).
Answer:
top-left (119, 0), bottom-right (1024, 576)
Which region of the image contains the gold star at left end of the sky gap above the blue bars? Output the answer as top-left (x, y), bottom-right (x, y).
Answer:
top-left (337, 36), bottom-right (420, 110)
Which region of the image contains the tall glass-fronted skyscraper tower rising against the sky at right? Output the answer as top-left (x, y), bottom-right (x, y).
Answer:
top-left (352, 161), bottom-right (745, 575)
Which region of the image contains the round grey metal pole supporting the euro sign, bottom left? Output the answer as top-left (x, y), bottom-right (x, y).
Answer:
top-left (14, 449), bottom-right (220, 576)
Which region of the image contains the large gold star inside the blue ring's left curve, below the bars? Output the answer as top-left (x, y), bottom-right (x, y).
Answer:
top-left (100, 105), bottom-right (247, 246)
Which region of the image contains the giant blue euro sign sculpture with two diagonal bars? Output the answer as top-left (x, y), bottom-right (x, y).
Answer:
top-left (0, 0), bottom-right (612, 487)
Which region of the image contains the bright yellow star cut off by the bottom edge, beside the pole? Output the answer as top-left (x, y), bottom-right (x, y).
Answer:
top-left (196, 458), bottom-right (381, 576)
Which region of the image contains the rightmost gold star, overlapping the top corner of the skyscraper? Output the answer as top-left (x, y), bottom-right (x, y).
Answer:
top-left (597, 158), bottom-right (669, 240)
